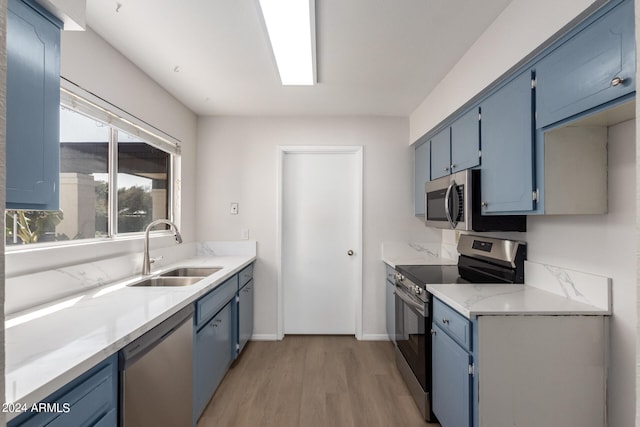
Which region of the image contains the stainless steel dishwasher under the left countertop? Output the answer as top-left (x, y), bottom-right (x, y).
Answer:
top-left (119, 305), bottom-right (193, 427)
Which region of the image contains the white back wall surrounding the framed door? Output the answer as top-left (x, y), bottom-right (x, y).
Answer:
top-left (196, 117), bottom-right (441, 339)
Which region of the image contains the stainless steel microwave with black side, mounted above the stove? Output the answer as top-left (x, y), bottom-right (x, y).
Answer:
top-left (425, 169), bottom-right (527, 231)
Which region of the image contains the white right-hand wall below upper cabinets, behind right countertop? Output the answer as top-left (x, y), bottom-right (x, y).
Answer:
top-left (526, 120), bottom-right (637, 427)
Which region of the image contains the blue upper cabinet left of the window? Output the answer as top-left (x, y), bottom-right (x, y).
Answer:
top-left (6, 0), bottom-right (62, 210)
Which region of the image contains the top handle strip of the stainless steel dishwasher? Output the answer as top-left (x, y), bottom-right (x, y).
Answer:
top-left (118, 304), bottom-right (194, 371)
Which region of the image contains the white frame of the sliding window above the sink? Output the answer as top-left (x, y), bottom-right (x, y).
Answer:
top-left (5, 78), bottom-right (181, 252)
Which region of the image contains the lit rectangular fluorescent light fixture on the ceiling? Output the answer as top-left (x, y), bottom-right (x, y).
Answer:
top-left (259, 0), bottom-right (316, 85)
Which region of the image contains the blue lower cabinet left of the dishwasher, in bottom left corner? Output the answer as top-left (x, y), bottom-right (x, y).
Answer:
top-left (8, 355), bottom-right (118, 427)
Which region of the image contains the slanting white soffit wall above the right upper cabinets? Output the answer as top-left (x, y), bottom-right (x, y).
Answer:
top-left (409, 0), bottom-right (595, 142)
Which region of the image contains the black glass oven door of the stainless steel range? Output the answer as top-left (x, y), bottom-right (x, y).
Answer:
top-left (395, 287), bottom-right (431, 391)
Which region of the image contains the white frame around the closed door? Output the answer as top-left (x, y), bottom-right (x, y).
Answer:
top-left (276, 145), bottom-right (363, 340)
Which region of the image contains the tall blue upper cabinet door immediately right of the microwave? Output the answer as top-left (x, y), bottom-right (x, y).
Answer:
top-left (480, 71), bottom-right (534, 214)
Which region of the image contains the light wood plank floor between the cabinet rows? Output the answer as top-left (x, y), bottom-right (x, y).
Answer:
top-left (198, 336), bottom-right (439, 427)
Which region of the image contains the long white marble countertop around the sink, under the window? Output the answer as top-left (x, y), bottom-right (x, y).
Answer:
top-left (5, 255), bottom-right (256, 420)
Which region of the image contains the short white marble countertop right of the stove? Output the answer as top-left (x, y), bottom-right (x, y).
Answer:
top-left (427, 284), bottom-right (610, 319)
